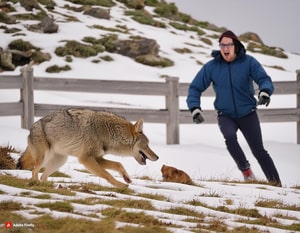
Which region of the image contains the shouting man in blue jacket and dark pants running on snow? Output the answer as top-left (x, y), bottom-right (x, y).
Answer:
top-left (187, 31), bottom-right (281, 187)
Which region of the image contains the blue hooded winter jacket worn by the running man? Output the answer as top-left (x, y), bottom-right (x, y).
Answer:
top-left (186, 49), bottom-right (274, 118)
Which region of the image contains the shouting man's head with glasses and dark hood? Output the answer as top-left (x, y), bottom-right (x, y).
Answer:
top-left (219, 31), bottom-right (245, 62)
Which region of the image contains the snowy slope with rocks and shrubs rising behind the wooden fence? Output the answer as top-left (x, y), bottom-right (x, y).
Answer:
top-left (0, 0), bottom-right (296, 80)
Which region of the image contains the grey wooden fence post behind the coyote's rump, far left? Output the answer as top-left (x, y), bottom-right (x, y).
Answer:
top-left (21, 66), bottom-right (34, 129)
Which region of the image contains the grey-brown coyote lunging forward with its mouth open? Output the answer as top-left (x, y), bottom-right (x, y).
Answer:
top-left (17, 109), bottom-right (158, 187)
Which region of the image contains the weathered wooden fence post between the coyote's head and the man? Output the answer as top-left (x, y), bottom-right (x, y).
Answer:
top-left (166, 77), bottom-right (179, 144)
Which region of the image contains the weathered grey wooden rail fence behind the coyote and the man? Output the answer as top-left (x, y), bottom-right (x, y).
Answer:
top-left (0, 66), bottom-right (300, 144)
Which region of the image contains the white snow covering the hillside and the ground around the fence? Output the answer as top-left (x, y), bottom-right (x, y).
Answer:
top-left (0, 1), bottom-right (300, 232)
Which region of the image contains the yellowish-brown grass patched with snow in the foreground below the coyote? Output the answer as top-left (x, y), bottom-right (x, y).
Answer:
top-left (0, 171), bottom-right (300, 233)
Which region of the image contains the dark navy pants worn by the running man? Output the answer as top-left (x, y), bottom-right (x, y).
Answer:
top-left (218, 111), bottom-right (281, 185)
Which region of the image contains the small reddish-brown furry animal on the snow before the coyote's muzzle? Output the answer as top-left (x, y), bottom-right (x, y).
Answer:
top-left (161, 165), bottom-right (193, 184)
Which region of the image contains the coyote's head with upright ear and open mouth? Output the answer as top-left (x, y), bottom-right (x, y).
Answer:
top-left (133, 119), bottom-right (158, 165)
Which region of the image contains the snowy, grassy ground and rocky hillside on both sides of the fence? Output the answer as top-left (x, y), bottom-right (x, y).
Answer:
top-left (0, 0), bottom-right (300, 233)
